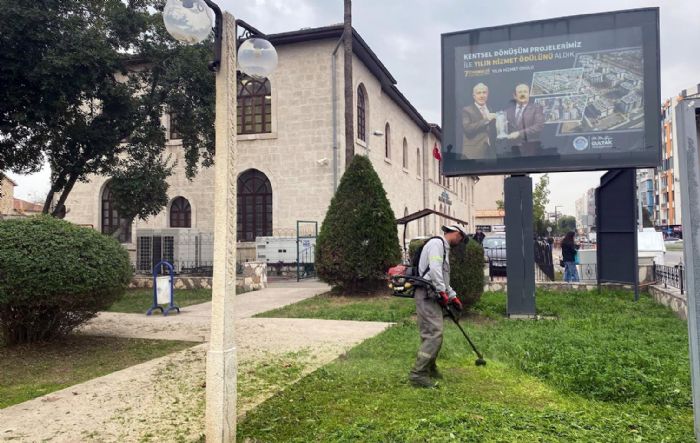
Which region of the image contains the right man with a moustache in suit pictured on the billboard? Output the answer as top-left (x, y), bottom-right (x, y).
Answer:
top-left (505, 83), bottom-right (544, 156)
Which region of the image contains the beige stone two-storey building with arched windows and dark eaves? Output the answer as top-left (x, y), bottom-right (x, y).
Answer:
top-left (66, 25), bottom-right (501, 266)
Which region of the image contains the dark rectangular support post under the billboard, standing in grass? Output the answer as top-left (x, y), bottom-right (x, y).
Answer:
top-left (504, 175), bottom-right (536, 318)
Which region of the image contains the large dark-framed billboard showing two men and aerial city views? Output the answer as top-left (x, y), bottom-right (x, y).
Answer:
top-left (442, 8), bottom-right (661, 176)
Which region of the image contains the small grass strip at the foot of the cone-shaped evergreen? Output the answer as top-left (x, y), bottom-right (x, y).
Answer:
top-left (255, 292), bottom-right (416, 322)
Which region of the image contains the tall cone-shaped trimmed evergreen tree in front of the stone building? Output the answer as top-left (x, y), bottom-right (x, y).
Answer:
top-left (316, 155), bottom-right (401, 293)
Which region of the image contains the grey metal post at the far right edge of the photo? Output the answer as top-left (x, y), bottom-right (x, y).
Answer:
top-left (675, 99), bottom-right (700, 441)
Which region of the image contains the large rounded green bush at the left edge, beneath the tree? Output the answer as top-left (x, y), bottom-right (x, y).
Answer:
top-left (0, 216), bottom-right (133, 345)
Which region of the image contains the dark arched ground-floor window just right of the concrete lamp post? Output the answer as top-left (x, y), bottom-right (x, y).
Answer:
top-left (236, 169), bottom-right (272, 242)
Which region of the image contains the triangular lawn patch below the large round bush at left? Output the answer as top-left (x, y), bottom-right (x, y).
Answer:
top-left (0, 335), bottom-right (194, 408)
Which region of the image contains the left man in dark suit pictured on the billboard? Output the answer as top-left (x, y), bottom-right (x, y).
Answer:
top-left (462, 83), bottom-right (496, 160)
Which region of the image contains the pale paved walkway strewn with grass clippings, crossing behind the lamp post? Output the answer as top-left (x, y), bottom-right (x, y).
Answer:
top-left (0, 282), bottom-right (389, 442)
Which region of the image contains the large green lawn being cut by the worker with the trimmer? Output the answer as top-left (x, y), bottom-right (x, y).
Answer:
top-left (238, 291), bottom-right (694, 442)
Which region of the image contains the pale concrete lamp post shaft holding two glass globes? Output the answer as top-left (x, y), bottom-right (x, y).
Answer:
top-left (206, 13), bottom-right (237, 443)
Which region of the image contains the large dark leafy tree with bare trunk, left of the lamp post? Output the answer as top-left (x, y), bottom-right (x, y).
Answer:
top-left (0, 0), bottom-right (214, 219)
